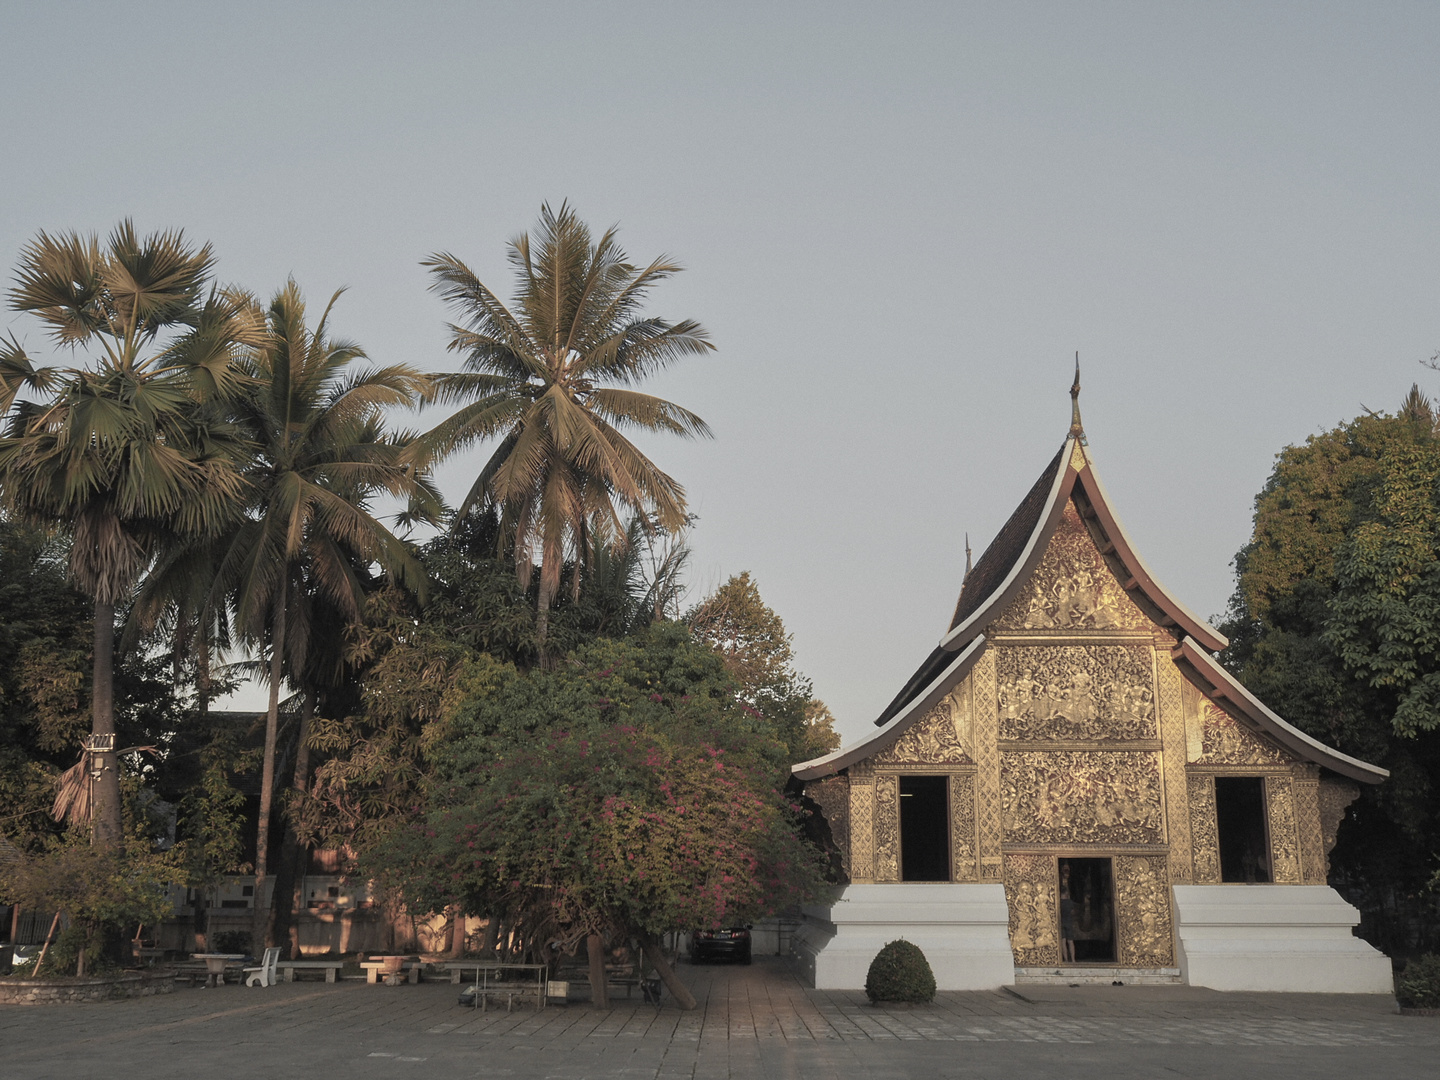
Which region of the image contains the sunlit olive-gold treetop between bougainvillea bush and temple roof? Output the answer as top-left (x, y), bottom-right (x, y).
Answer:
top-left (685, 570), bottom-right (840, 762)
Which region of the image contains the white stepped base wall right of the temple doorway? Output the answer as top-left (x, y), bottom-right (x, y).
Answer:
top-left (1175, 886), bottom-right (1394, 994)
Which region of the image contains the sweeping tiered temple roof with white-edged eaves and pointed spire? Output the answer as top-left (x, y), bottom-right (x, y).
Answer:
top-left (792, 383), bottom-right (1390, 783)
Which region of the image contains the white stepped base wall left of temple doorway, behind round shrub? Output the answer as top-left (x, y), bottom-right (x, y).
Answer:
top-left (795, 884), bottom-right (1015, 991)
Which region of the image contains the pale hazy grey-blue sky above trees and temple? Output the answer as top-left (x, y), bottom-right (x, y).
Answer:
top-left (0, 0), bottom-right (1440, 737)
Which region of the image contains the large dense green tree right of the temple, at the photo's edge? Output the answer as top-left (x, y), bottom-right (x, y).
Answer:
top-left (1221, 390), bottom-right (1440, 952)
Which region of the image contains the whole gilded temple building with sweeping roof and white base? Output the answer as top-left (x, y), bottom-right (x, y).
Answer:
top-left (793, 383), bottom-right (1392, 994)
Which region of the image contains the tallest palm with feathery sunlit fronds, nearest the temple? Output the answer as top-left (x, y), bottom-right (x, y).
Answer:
top-left (422, 204), bottom-right (714, 649)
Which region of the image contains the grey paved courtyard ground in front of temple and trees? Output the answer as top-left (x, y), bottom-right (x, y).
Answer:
top-left (0, 959), bottom-right (1440, 1080)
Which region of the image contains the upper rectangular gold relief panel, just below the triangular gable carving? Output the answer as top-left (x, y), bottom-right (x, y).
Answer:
top-left (996, 645), bottom-right (1158, 742)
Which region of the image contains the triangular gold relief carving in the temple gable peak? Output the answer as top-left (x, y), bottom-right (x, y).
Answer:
top-left (995, 501), bottom-right (1153, 629)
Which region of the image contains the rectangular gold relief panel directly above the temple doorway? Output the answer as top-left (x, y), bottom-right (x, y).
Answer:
top-left (1001, 750), bottom-right (1165, 844)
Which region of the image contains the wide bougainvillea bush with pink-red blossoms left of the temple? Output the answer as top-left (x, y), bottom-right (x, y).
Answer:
top-left (369, 624), bottom-right (824, 946)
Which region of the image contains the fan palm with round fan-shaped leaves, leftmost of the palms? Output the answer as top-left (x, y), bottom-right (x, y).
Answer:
top-left (0, 220), bottom-right (255, 847)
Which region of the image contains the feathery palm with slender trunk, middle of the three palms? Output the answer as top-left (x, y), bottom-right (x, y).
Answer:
top-left (217, 281), bottom-right (441, 933)
